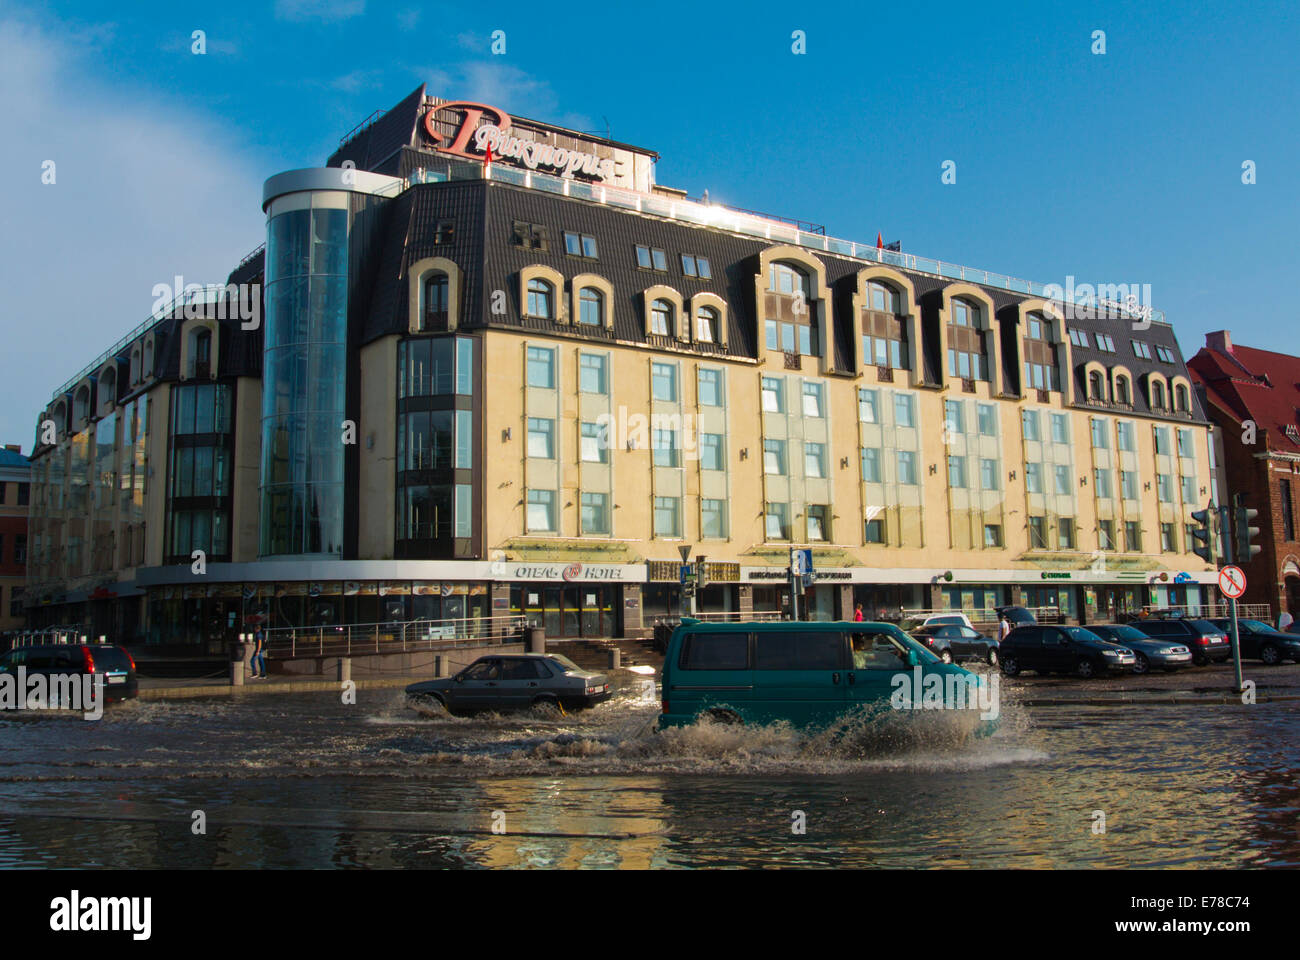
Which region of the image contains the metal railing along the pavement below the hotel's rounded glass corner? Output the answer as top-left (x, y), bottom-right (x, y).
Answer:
top-left (267, 615), bottom-right (532, 660)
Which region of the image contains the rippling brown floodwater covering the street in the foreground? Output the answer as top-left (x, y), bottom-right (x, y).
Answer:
top-left (0, 678), bottom-right (1300, 868)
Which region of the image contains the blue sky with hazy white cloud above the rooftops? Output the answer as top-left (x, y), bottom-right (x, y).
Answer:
top-left (0, 0), bottom-right (1300, 450)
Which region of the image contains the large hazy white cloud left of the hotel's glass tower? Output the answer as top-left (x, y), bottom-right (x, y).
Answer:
top-left (0, 20), bottom-right (267, 450)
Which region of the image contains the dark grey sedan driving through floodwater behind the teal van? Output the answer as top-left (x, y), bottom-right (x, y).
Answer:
top-left (406, 653), bottom-right (610, 715)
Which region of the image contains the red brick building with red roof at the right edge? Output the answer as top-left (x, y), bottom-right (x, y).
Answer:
top-left (1187, 330), bottom-right (1300, 619)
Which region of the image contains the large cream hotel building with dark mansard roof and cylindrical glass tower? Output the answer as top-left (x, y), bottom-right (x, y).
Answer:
top-left (17, 87), bottom-right (1214, 645)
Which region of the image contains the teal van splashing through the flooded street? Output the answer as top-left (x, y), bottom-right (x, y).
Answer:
top-left (659, 618), bottom-right (997, 734)
